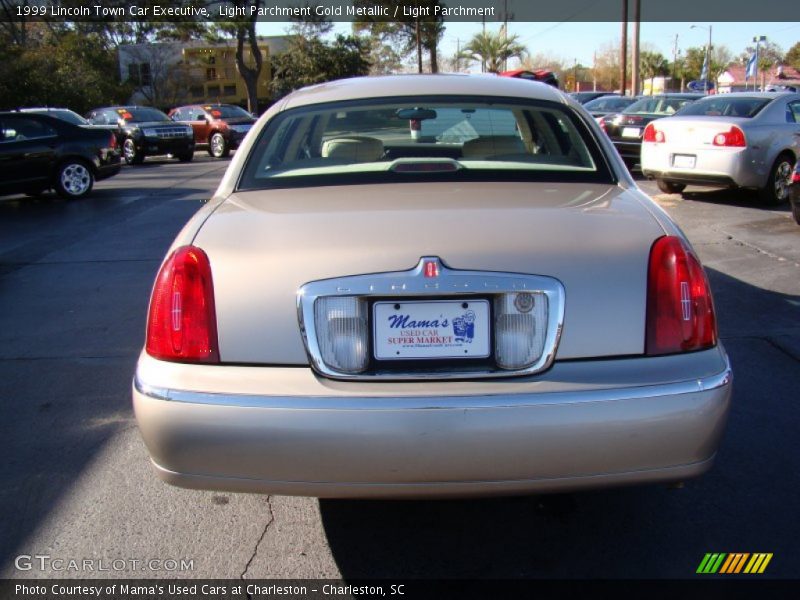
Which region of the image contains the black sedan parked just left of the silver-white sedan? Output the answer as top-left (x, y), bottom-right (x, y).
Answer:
top-left (603, 94), bottom-right (703, 168)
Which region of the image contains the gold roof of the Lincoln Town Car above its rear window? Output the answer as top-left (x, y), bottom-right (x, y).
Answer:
top-left (283, 73), bottom-right (568, 109)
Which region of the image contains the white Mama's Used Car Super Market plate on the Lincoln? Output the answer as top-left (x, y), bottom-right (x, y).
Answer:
top-left (372, 300), bottom-right (490, 360)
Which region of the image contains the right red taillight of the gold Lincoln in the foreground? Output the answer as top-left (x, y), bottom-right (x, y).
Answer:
top-left (645, 236), bottom-right (717, 355)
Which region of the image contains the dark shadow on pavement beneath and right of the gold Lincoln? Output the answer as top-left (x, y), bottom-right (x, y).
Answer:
top-left (320, 271), bottom-right (800, 579)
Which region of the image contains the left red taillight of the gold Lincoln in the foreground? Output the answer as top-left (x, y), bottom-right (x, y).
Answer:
top-left (146, 246), bottom-right (219, 363)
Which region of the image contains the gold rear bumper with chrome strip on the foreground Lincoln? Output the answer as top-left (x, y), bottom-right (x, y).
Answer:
top-left (133, 348), bottom-right (731, 497)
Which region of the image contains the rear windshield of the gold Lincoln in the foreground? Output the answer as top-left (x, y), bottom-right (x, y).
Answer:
top-left (239, 97), bottom-right (612, 189)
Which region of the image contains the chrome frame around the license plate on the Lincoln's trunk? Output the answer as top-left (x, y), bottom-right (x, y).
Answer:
top-left (297, 256), bottom-right (566, 381)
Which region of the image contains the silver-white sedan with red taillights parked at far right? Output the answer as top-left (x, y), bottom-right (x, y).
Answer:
top-left (642, 92), bottom-right (800, 204)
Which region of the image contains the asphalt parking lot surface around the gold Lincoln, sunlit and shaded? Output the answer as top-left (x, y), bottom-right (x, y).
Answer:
top-left (0, 153), bottom-right (800, 579)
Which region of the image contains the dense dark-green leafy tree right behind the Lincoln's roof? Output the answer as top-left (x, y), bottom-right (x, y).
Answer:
top-left (270, 34), bottom-right (370, 100)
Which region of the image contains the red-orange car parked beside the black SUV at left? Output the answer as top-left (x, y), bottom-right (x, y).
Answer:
top-left (169, 104), bottom-right (256, 158)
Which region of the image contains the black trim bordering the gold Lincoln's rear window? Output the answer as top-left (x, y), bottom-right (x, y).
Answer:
top-left (234, 94), bottom-right (618, 192)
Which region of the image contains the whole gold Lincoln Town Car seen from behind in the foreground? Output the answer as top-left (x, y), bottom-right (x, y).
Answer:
top-left (133, 75), bottom-right (731, 497)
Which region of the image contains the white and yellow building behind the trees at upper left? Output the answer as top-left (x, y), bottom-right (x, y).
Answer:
top-left (119, 36), bottom-right (287, 109)
